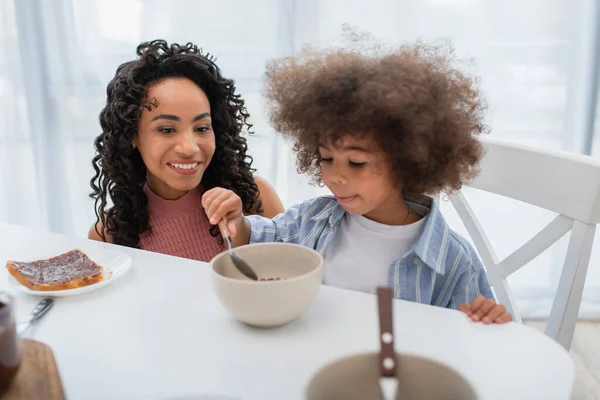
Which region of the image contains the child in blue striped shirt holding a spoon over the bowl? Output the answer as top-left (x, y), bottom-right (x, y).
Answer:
top-left (203, 40), bottom-right (511, 323)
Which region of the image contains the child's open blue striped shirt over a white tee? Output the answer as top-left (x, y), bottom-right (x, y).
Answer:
top-left (248, 196), bottom-right (494, 309)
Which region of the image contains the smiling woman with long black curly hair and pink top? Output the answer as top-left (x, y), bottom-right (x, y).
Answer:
top-left (89, 40), bottom-right (283, 261)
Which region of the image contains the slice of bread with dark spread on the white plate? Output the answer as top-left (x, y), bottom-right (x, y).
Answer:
top-left (6, 249), bottom-right (104, 291)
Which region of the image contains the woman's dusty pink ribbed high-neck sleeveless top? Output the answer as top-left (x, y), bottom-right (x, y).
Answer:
top-left (139, 184), bottom-right (226, 261)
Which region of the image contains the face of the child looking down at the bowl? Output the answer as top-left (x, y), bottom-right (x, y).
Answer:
top-left (319, 136), bottom-right (405, 225)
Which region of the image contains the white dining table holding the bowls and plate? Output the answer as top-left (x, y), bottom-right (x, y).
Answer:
top-left (0, 224), bottom-right (574, 400)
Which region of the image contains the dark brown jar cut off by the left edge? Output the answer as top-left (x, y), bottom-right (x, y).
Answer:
top-left (0, 292), bottom-right (20, 395)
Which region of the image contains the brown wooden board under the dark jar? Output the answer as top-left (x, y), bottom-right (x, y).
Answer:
top-left (0, 340), bottom-right (65, 400)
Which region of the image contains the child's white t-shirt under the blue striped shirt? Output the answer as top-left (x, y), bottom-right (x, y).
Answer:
top-left (323, 213), bottom-right (427, 293)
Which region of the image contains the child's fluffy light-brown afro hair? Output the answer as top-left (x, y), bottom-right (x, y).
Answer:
top-left (264, 43), bottom-right (488, 196)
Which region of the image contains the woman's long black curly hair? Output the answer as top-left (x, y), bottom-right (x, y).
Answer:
top-left (90, 40), bottom-right (261, 247)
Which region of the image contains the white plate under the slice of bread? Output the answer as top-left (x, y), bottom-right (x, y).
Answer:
top-left (8, 248), bottom-right (131, 297)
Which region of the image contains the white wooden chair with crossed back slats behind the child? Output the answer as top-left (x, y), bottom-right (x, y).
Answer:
top-left (450, 138), bottom-right (600, 350)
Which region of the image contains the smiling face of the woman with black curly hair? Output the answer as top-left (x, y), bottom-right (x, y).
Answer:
top-left (131, 78), bottom-right (215, 199)
